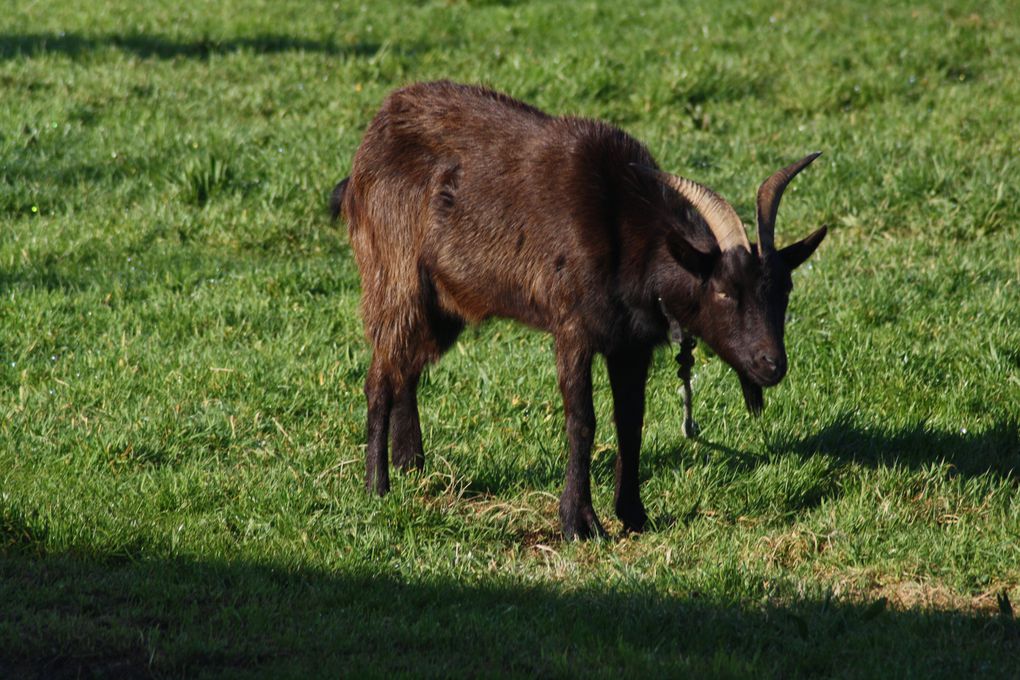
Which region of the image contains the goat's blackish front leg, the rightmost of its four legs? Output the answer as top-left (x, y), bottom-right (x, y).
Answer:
top-left (606, 350), bottom-right (652, 531)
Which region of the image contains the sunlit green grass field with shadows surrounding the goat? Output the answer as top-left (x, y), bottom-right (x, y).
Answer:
top-left (0, 0), bottom-right (1020, 678)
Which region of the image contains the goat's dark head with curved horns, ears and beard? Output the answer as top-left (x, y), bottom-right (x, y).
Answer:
top-left (655, 153), bottom-right (826, 414)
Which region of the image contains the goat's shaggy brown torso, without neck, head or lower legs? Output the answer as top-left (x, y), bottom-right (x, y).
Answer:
top-left (344, 82), bottom-right (654, 336)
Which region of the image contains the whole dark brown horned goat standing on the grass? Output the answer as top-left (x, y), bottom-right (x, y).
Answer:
top-left (332, 82), bottom-right (825, 539)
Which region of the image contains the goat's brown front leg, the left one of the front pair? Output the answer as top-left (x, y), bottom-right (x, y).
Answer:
top-left (556, 337), bottom-right (607, 540)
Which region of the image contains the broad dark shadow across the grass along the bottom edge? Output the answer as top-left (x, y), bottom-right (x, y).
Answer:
top-left (0, 552), bottom-right (1020, 678)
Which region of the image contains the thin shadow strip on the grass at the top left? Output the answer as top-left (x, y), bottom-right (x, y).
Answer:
top-left (0, 33), bottom-right (385, 59)
